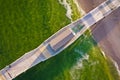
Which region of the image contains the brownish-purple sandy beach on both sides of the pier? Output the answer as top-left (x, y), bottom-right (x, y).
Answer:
top-left (78, 0), bottom-right (120, 69)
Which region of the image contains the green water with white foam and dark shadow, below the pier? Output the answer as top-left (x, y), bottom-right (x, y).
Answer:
top-left (15, 34), bottom-right (119, 80)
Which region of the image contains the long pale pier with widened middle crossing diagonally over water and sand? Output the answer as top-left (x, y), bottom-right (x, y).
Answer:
top-left (0, 0), bottom-right (120, 80)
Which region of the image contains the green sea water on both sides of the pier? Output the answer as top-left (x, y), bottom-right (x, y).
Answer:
top-left (0, 0), bottom-right (119, 80)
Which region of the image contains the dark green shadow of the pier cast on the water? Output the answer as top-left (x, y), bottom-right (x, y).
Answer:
top-left (14, 30), bottom-right (96, 80)
